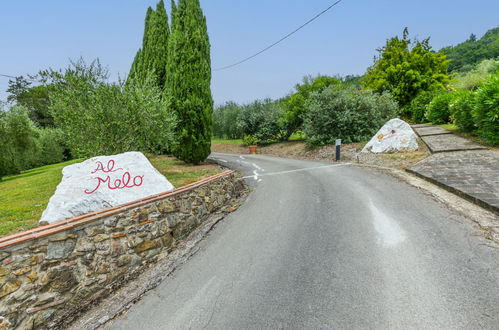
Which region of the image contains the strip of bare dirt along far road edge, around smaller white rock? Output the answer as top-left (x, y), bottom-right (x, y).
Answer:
top-left (211, 141), bottom-right (430, 169)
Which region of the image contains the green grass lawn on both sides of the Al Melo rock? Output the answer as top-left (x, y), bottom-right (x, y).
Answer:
top-left (0, 155), bottom-right (221, 237)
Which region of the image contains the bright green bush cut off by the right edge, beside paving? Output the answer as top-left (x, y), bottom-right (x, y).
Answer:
top-left (473, 74), bottom-right (499, 145)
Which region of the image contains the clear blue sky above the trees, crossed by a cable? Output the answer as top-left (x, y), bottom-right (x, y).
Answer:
top-left (0, 0), bottom-right (499, 104)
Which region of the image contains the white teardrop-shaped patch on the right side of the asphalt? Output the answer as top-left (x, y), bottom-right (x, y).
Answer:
top-left (369, 200), bottom-right (407, 247)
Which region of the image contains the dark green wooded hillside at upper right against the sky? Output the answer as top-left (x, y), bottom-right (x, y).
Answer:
top-left (440, 27), bottom-right (499, 72)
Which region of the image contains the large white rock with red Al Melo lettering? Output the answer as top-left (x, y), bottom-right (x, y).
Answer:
top-left (40, 152), bottom-right (175, 223)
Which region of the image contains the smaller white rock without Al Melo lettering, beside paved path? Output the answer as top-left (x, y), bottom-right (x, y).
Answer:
top-left (362, 118), bottom-right (418, 153)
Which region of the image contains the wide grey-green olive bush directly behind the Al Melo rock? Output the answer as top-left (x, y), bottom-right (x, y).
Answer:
top-left (47, 61), bottom-right (176, 157)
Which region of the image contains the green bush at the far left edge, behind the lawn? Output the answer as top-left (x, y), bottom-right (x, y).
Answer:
top-left (0, 106), bottom-right (39, 178)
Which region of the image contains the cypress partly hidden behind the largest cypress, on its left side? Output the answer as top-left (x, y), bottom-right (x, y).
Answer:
top-left (128, 0), bottom-right (170, 89)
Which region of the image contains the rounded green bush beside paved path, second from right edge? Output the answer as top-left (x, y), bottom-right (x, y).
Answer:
top-left (450, 91), bottom-right (475, 132)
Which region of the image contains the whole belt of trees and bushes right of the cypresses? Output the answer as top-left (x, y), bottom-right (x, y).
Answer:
top-left (213, 28), bottom-right (499, 147)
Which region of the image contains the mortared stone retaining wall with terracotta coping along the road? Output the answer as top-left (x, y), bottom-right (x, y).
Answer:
top-left (0, 171), bottom-right (244, 329)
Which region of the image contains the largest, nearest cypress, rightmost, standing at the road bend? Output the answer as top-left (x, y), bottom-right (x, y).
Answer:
top-left (165, 0), bottom-right (213, 164)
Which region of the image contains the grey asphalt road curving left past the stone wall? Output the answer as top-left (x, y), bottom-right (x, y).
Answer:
top-left (106, 154), bottom-right (499, 329)
